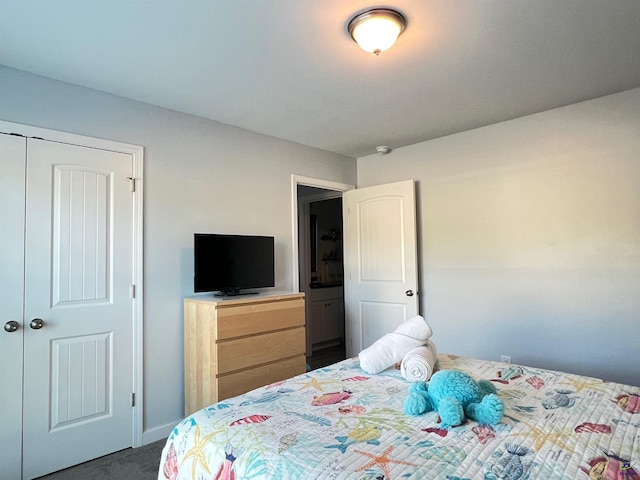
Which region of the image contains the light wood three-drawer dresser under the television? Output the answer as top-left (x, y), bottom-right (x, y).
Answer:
top-left (184, 293), bottom-right (306, 415)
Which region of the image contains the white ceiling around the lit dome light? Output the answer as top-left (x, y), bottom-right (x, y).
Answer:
top-left (0, 0), bottom-right (640, 157)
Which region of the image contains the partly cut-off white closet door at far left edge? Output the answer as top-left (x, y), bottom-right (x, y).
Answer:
top-left (0, 134), bottom-right (26, 478)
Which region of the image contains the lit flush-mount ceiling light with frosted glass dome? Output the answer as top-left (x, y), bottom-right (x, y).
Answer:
top-left (348, 8), bottom-right (407, 55)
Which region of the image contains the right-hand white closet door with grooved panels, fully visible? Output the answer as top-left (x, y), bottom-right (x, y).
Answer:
top-left (22, 139), bottom-right (134, 478)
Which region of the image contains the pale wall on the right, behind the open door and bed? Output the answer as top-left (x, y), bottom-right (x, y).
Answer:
top-left (358, 89), bottom-right (640, 385)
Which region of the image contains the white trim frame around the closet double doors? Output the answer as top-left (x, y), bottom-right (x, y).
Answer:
top-left (0, 120), bottom-right (144, 447)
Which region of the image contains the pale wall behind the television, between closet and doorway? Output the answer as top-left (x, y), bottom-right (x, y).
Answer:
top-left (0, 66), bottom-right (356, 441)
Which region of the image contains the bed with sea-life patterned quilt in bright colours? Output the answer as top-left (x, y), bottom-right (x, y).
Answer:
top-left (158, 354), bottom-right (640, 480)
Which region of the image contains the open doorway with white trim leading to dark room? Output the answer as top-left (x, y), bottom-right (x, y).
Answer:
top-left (293, 176), bottom-right (354, 369)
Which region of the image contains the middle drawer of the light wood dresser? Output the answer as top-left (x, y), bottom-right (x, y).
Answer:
top-left (218, 327), bottom-right (305, 376)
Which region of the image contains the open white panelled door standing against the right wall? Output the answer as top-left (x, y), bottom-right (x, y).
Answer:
top-left (343, 180), bottom-right (419, 356)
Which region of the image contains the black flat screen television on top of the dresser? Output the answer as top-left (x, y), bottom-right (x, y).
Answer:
top-left (193, 233), bottom-right (275, 296)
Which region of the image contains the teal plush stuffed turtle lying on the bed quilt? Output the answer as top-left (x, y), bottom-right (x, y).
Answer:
top-left (404, 370), bottom-right (504, 428)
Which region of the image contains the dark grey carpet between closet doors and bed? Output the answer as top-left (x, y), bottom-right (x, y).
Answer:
top-left (36, 440), bottom-right (165, 480)
